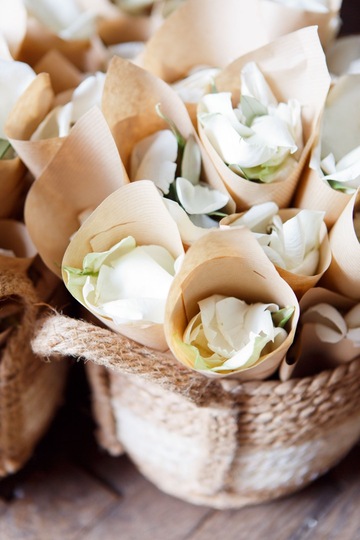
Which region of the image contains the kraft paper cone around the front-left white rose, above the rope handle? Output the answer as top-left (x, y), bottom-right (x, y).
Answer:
top-left (62, 181), bottom-right (183, 351)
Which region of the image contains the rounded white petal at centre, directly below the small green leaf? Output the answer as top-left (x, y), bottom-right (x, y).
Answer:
top-left (176, 177), bottom-right (229, 214)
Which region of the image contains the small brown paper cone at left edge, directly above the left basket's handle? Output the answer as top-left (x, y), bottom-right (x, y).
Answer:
top-left (0, 219), bottom-right (37, 272)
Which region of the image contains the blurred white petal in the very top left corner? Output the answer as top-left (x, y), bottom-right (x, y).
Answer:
top-left (0, 0), bottom-right (27, 58)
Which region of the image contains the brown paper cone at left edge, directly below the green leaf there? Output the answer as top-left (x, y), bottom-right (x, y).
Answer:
top-left (0, 157), bottom-right (27, 218)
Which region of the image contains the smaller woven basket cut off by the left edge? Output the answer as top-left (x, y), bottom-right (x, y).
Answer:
top-left (0, 270), bottom-right (67, 477)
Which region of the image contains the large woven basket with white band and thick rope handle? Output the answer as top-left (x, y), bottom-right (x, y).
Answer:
top-left (33, 315), bottom-right (360, 508)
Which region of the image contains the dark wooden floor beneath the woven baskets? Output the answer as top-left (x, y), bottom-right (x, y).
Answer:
top-left (0, 364), bottom-right (360, 540)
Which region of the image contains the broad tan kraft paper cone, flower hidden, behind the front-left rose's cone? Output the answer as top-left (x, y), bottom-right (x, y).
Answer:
top-left (25, 108), bottom-right (127, 275)
